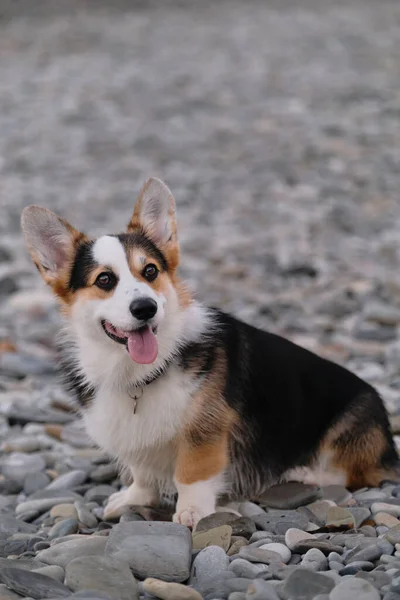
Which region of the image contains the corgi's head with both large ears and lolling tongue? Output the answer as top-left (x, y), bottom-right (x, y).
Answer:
top-left (22, 179), bottom-right (190, 365)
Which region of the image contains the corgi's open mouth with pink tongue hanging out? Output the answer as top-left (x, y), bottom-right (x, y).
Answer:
top-left (101, 319), bottom-right (158, 365)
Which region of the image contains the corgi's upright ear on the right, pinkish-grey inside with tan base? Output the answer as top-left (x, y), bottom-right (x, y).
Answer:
top-left (128, 177), bottom-right (179, 267)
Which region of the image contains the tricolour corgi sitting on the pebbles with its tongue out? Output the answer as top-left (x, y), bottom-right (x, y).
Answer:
top-left (22, 178), bottom-right (398, 528)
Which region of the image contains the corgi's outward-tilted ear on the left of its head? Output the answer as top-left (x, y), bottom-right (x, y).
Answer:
top-left (21, 205), bottom-right (84, 288)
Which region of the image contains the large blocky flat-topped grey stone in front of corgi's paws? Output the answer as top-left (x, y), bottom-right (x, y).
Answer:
top-left (106, 521), bottom-right (192, 583)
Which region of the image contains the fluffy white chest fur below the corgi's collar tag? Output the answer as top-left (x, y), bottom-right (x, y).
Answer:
top-left (84, 368), bottom-right (193, 477)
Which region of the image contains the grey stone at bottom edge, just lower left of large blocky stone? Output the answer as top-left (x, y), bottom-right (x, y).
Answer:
top-left (65, 556), bottom-right (139, 600)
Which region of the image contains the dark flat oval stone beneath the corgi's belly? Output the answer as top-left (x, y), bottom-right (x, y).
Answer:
top-left (259, 481), bottom-right (322, 510)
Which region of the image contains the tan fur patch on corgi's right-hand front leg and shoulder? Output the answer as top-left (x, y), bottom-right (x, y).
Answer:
top-left (175, 350), bottom-right (236, 484)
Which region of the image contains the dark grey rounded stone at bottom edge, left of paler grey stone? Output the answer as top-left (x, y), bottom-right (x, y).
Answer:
top-left (280, 568), bottom-right (334, 600)
